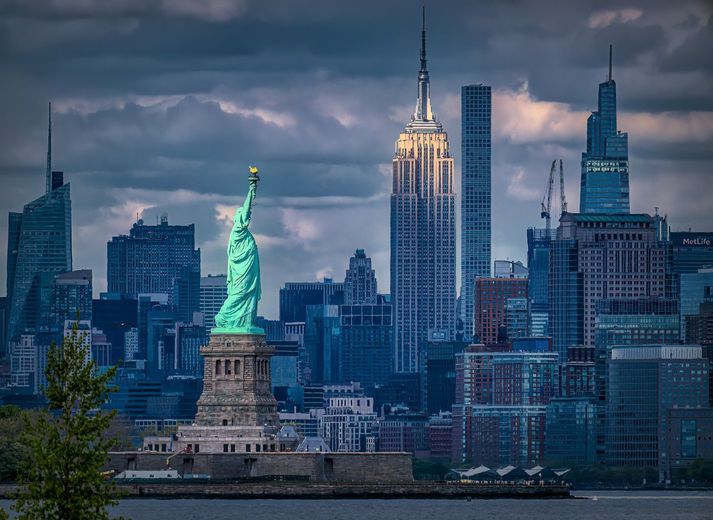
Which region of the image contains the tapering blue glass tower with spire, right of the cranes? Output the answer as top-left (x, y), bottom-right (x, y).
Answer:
top-left (579, 46), bottom-right (629, 213)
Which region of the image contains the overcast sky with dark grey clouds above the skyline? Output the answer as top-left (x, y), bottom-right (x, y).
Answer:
top-left (0, 0), bottom-right (713, 318)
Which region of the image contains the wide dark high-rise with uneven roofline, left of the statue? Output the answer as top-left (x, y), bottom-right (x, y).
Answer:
top-left (107, 215), bottom-right (201, 323)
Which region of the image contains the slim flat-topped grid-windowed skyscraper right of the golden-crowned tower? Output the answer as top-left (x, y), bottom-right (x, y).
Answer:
top-left (460, 85), bottom-right (491, 341)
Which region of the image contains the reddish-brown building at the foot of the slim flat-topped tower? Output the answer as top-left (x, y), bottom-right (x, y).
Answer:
top-left (473, 278), bottom-right (527, 345)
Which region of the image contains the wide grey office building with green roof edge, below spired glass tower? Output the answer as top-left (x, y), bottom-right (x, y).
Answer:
top-left (549, 213), bottom-right (670, 358)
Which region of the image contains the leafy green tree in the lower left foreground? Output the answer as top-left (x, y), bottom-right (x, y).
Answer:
top-left (13, 323), bottom-right (124, 520)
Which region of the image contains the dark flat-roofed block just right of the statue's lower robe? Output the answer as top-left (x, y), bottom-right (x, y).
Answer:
top-left (280, 278), bottom-right (344, 323)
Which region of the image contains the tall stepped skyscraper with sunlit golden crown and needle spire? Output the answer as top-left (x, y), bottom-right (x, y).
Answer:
top-left (391, 10), bottom-right (456, 373)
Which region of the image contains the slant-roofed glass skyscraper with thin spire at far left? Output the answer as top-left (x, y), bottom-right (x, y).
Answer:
top-left (3, 107), bottom-right (72, 348)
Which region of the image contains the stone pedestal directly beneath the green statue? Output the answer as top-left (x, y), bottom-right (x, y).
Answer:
top-left (196, 333), bottom-right (280, 434)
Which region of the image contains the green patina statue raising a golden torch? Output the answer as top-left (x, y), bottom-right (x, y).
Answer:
top-left (211, 166), bottom-right (265, 334)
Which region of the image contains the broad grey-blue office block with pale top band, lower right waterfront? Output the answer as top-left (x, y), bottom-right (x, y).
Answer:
top-left (607, 345), bottom-right (709, 481)
